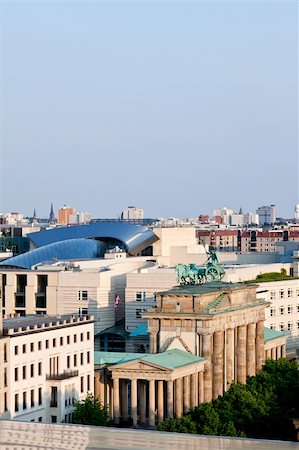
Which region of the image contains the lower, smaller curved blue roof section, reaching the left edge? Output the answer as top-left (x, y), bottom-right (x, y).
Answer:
top-left (0, 239), bottom-right (105, 269)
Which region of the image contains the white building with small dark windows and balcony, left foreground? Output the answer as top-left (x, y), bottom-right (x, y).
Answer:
top-left (0, 316), bottom-right (94, 423)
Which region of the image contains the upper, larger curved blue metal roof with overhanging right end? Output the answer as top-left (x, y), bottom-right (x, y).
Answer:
top-left (28, 221), bottom-right (158, 255)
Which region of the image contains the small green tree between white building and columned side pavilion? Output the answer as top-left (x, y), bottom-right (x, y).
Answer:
top-left (73, 394), bottom-right (108, 426)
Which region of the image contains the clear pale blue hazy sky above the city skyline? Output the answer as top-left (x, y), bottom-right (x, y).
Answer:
top-left (0, 0), bottom-right (299, 217)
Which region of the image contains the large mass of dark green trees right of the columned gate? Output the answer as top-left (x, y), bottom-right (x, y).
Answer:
top-left (158, 359), bottom-right (299, 440)
